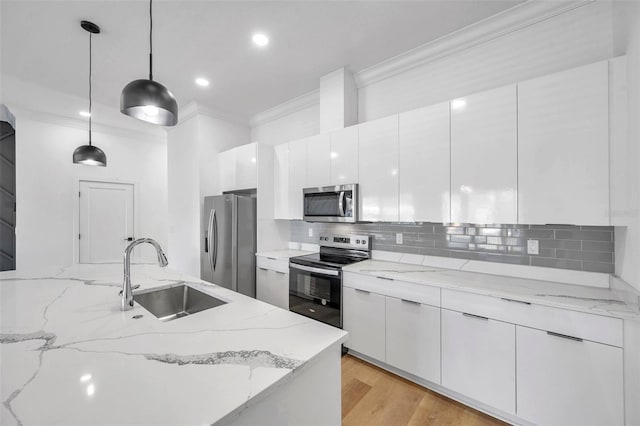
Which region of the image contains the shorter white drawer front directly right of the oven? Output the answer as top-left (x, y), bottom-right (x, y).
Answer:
top-left (342, 271), bottom-right (440, 307)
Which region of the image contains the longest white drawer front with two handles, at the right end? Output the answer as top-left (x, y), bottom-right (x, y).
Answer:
top-left (442, 289), bottom-right (622, 347)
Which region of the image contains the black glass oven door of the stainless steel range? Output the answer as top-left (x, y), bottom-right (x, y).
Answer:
top-left (289, 263), bottom-right (342, 328)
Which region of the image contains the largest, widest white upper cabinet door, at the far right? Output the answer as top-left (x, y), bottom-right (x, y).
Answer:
top-left (518, 61), bottom-right (609, 225)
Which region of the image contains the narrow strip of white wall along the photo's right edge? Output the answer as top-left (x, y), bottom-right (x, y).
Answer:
top-left (612, 2), bottom-right (640, 290)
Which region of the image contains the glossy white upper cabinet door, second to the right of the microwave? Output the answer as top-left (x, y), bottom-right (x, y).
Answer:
top-left (399, 102), bottom-right (451, 222)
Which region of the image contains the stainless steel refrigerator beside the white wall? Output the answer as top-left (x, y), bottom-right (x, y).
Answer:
top-left (200, 195), bottom-right (256, 297)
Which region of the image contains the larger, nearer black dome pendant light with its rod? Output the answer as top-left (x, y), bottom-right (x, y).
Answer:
top-left (120, 0), bottom-right (178, 126)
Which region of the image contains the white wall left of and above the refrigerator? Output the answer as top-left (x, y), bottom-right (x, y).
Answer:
top-left (167, 110), bottom-right (250, 277)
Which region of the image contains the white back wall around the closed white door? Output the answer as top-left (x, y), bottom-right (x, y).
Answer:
top-left (12, 109), bottom-right (168, 271)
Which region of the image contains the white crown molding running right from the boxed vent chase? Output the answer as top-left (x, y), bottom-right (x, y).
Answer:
top-left (354, 0), bottom-right (595, 88)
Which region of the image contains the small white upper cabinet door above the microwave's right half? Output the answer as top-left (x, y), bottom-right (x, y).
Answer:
top-left (329, 126), bottom-right (358, 185)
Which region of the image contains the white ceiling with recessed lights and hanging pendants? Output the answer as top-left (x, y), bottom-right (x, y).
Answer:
top-left (0, 0), bottom-right (522, 118)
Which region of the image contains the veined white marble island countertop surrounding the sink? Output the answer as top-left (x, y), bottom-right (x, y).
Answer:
top-left (0, 265), bottom-right (347, 425)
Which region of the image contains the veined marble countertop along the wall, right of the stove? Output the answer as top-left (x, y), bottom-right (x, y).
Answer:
top-left (343, 260), bottom-right (640, 319)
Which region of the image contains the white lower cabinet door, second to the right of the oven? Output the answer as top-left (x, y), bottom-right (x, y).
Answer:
top-left (386, 297), bottom-right (440, 384)
